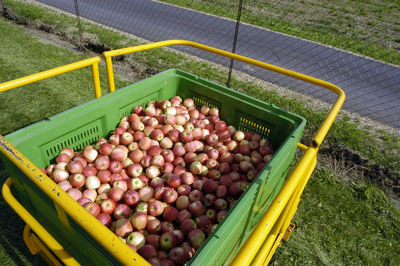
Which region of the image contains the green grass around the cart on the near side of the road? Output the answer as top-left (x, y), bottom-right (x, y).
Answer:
top-left (0, 1), bottom-right (400, 265)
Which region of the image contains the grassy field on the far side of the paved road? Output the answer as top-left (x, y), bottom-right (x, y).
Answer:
top-left (160, 0), bottom-right (400, 65)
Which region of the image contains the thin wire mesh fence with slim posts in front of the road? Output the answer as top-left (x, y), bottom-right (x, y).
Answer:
top-left (3, 0), bottom-right (400, 128)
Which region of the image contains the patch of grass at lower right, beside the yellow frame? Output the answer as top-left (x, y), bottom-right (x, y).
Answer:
top-left (273, 167), bottom-right (400, 265)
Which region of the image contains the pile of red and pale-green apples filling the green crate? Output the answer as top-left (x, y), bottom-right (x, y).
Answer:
top-left (42, 96), bottom-right (274, 265)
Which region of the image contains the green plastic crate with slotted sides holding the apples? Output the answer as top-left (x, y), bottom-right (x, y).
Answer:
top-left (2, 69), bottom-right (306, 265)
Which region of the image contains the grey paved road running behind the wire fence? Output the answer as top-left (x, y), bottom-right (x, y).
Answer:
top-left (40, 0), bottom-right (400, 128)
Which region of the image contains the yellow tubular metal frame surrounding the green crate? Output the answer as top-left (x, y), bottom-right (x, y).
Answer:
top-left (0, 40), bottom-right (345, 265)
